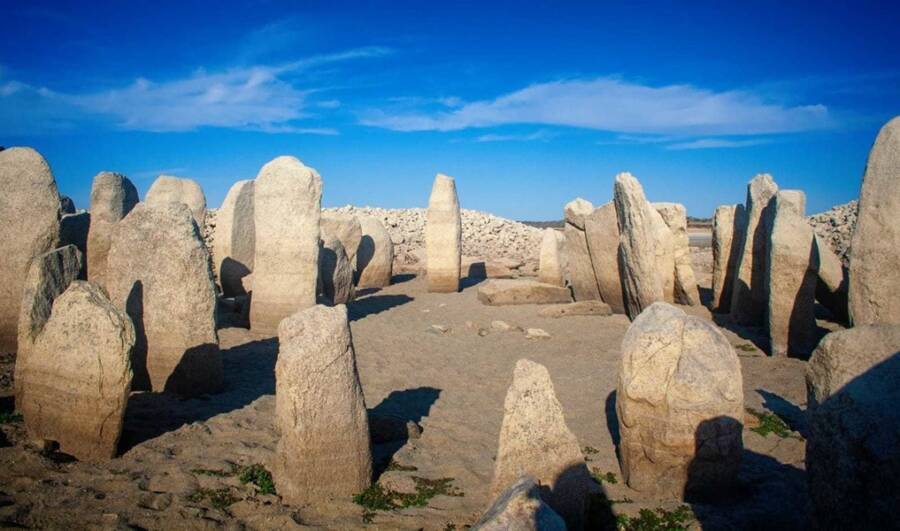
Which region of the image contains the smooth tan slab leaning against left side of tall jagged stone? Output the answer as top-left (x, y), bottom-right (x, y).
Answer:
top-left (584, 202), bottom-right (625, 313)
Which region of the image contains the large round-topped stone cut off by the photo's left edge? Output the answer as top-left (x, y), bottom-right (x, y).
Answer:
top-left (0, 147), bottom-right (60, 352)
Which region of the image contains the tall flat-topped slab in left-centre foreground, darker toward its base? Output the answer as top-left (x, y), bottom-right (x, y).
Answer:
top-left (272, 305), bottom-right (372, 505)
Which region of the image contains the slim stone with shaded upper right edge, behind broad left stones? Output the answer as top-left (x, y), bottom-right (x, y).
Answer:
top-left (87, 171), bottom-right (139, 286)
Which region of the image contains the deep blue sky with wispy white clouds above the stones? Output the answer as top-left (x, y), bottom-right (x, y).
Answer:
top-left (0, 0), bottom-right (900, 219)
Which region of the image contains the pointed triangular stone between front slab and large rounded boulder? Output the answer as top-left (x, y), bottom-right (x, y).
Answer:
top-left (491, 360), bottom-right (592, 529)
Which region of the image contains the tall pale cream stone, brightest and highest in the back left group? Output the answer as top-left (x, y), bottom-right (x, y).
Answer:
top-left (250, 157), bottom-right (322, 334)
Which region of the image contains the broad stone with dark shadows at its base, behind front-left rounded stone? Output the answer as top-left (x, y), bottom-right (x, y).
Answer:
top-left (106, 203), bottom-right (222, 396)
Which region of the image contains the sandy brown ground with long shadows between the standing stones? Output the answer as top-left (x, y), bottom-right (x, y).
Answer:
top-left (0, 244), bottom-right (807, 529)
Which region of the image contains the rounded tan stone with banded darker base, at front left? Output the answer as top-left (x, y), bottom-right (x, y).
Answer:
top-left (21, 281), bottom-right (135, 462)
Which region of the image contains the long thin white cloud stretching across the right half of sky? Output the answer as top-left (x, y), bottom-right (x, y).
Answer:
top-left (361, 78), bottom-right (831, 136)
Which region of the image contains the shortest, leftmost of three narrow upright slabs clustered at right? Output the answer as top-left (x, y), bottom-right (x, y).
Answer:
top-left (711, 205), bottom-right (747, 313)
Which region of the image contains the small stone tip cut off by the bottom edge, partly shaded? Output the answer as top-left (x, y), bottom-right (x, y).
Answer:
top-left (472, 476), bottom-right (566, 531)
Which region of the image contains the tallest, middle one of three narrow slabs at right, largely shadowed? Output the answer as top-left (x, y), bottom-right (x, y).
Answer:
top-left (730, 174), bottom-right (778, 325)
